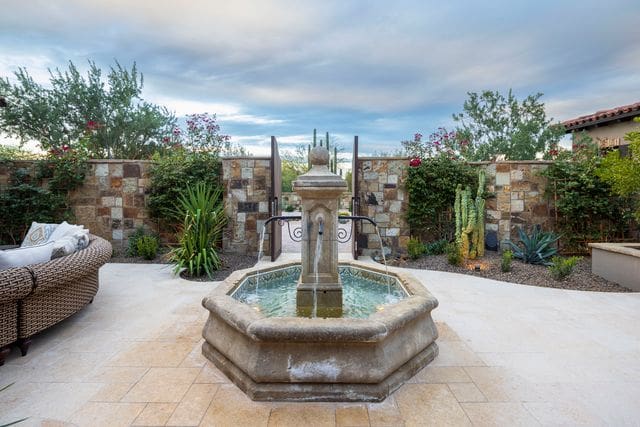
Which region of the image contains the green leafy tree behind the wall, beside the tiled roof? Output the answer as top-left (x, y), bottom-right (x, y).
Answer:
top-left (453, 90), bottom-right (564, 160)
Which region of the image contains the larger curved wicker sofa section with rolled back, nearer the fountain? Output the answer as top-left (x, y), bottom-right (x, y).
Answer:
top-left (18, 235), bottom-right (112, 356)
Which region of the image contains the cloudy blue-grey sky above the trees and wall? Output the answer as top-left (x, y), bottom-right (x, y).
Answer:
top-left (0, 0), bottom-right (640, 154)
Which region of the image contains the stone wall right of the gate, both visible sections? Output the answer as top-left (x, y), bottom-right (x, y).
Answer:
top-left (355, 157), bottom-right (554, 255)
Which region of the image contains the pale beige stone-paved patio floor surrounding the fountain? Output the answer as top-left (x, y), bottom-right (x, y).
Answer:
top-left (0, 264), bottom-right (640, 426)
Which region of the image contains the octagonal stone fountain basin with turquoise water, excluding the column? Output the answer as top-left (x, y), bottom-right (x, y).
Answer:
top-left (202, 261), bottom-right (438, 402)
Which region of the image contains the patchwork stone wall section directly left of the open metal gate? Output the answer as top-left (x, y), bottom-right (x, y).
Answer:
top-left (222, 157), bottom-right (271, 255)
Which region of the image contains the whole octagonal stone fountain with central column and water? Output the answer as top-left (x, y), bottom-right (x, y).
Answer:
top-left (202, 147), bottom-right (438, 401)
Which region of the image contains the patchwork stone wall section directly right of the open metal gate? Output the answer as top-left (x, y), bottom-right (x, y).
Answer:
top-left (353, 157), bottom-right (409, 255)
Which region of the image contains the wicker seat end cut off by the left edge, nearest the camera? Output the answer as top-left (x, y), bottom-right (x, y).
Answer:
top-left (0, 267), bottom-right (33, 366)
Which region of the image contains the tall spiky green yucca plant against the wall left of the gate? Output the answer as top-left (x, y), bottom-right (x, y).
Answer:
top-left (170, 182), bottom-right (227, 277)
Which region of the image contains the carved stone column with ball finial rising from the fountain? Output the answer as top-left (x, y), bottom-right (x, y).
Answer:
top-left (293, 147), bottom-right (347, 317)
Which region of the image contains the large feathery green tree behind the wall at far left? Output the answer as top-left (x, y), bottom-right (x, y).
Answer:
top-left (0, 61), bottom-right (175, 159)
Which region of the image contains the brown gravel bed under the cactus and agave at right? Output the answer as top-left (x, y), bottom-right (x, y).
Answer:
top-left (389, 251), bottom-right (632, 292)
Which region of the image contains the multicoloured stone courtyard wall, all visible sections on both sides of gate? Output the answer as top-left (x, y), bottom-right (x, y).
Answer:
top-left (0, 157), bottom-right (554, 255)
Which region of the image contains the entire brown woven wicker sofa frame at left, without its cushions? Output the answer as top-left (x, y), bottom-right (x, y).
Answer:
top-left (0, 235), bottom-right (112, 365)
